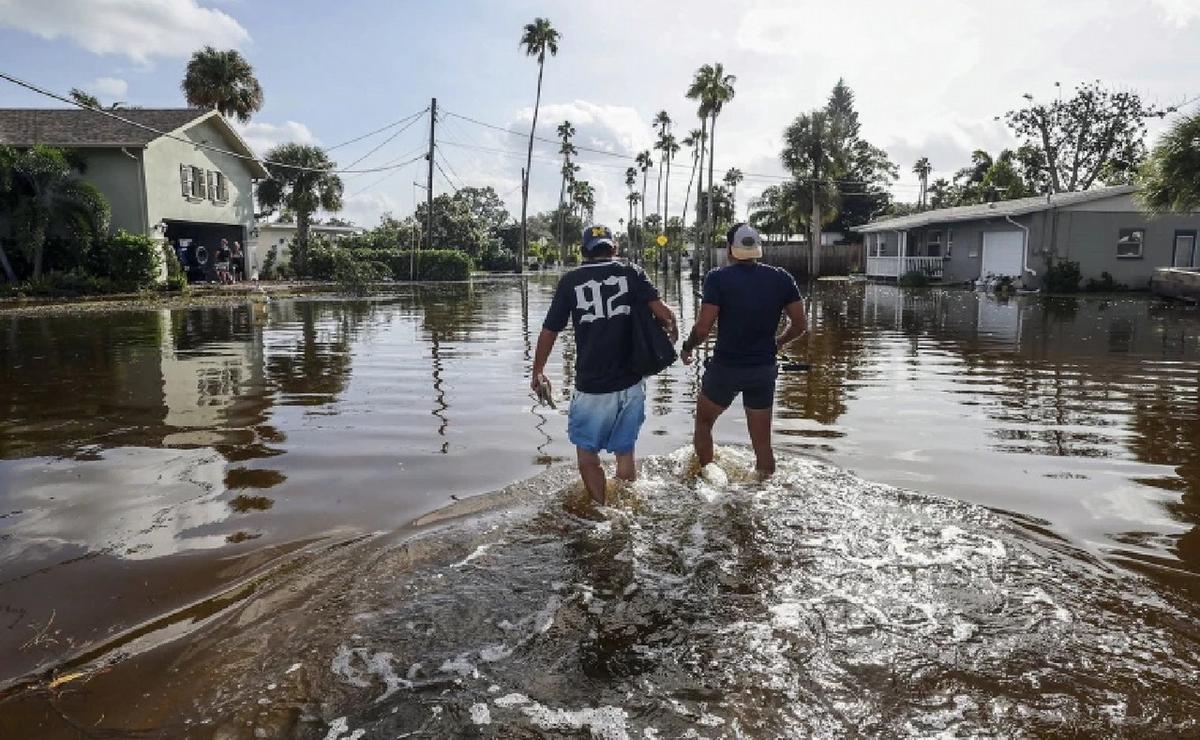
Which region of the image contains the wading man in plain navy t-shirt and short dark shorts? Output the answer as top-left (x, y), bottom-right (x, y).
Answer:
top-left (679, 223), bottom-right (808, 475)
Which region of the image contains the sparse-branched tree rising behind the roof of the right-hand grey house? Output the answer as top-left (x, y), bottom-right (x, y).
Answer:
top-left (1004, 82), bottom-right (1165, 193)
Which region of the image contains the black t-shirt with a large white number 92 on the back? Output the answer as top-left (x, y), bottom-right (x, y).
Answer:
top-left (542, 260), bottom-right (659, 393)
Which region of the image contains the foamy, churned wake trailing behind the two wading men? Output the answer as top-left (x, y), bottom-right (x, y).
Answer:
top-left (300, 450), bottom-right (1200, 740)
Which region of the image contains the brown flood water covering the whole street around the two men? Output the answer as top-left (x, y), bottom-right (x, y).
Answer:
top-left (0, 276), bottom-right (1200, 740)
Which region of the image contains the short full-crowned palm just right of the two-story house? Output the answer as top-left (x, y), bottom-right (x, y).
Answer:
top-left (256, 144), bottom-right (342, 275)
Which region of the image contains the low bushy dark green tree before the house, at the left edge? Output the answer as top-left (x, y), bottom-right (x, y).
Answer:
top-left (0, 146), bottom-right (110, 282)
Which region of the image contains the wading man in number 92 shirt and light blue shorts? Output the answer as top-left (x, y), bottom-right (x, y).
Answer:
top-left (530, 225), bottom-right (678, 504)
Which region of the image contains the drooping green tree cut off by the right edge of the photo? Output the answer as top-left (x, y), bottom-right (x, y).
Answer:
top-left (1138, 114), bottom-right (1200, 213)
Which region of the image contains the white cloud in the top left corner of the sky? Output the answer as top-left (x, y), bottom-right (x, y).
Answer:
top-left (0, 0), bottom-right (250, 64)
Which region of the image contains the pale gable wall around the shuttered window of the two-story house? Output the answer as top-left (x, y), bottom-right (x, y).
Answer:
top-left (145, 121), bottom-right (254, 229)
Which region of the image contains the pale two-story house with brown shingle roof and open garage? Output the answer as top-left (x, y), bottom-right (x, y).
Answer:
top-left (0, 108), bottom-right (269, 281)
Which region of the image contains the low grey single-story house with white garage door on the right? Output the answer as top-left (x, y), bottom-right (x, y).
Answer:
top-left (856, 186), bottom-right (1200, 288)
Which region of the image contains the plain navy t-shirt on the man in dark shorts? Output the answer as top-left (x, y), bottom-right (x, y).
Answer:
top-left (703, 263), bottom-right (800, 367)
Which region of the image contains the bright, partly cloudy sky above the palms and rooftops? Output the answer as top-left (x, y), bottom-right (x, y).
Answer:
top-left (0, 0), bottom-right (1200, 225)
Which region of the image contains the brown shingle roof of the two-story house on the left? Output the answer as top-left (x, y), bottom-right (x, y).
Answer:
top-left (0, 108), bottom-right (210, 146)
